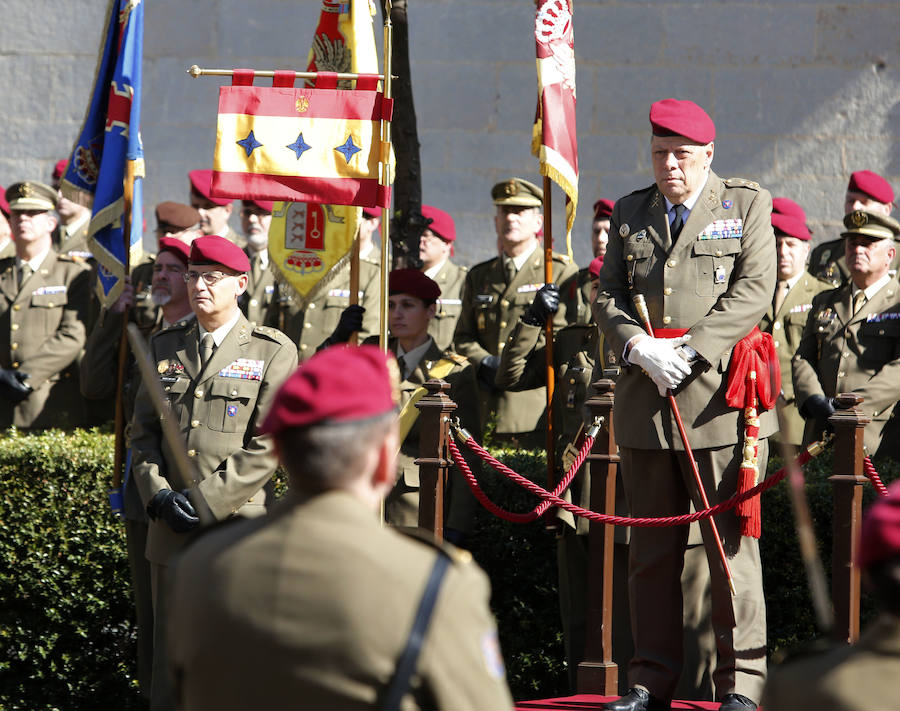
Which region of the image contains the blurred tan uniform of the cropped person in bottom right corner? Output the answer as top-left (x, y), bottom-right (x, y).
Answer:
top-left (762, 614), bottom-right (900, 711)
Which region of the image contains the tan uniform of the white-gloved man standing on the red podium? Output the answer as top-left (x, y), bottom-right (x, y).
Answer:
top-left (594, 172), bottom-right (776, 700)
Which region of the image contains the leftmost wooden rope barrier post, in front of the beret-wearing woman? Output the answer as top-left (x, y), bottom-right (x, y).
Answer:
top-left (415, 379), bottom-right (456, 541)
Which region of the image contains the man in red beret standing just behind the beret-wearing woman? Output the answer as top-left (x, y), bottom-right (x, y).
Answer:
top-left (419, 205), bottom-right (468, 350)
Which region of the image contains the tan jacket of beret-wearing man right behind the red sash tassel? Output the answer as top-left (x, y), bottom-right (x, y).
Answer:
top-left (759, 271), bottom-right (828, 447)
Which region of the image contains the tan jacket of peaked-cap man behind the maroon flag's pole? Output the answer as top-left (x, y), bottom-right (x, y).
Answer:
top-left (453, 247), bottom-right (578, 434)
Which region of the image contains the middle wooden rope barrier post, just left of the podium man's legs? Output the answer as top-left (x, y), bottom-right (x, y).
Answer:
top-left (577, 380), bottom-right (627, 696)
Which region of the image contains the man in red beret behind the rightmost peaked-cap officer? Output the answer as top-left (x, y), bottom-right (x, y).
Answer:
top-left (809, 170), bottom-right (900, 287)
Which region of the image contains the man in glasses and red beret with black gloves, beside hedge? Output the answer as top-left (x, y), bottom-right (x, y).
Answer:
top-left (132, 235), bottom-right (297, 709)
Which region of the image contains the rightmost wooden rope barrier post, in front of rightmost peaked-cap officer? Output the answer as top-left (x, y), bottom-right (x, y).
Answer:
top-left (828, 394), bottom-right (872, 644)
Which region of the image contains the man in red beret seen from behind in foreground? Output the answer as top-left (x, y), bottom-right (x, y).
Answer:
top-left (168, 346), bottom-right (512, 711)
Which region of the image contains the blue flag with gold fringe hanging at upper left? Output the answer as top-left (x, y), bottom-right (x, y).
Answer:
top-left (60, 0), bottom-right (144, 306)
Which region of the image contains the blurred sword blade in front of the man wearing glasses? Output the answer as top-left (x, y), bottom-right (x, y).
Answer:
top-left (128, 323), bottom-right (216, 526)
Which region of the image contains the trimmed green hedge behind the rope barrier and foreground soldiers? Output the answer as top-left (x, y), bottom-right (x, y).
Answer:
top-left (0, 430), bottom-right (897, 711)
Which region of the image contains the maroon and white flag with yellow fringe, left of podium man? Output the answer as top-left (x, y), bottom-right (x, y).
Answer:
top-left (531, 0), bottom-right (578, 257)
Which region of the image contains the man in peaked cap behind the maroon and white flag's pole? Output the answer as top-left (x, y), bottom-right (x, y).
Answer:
top-left (453, 178), bottom-right (578, 449)
